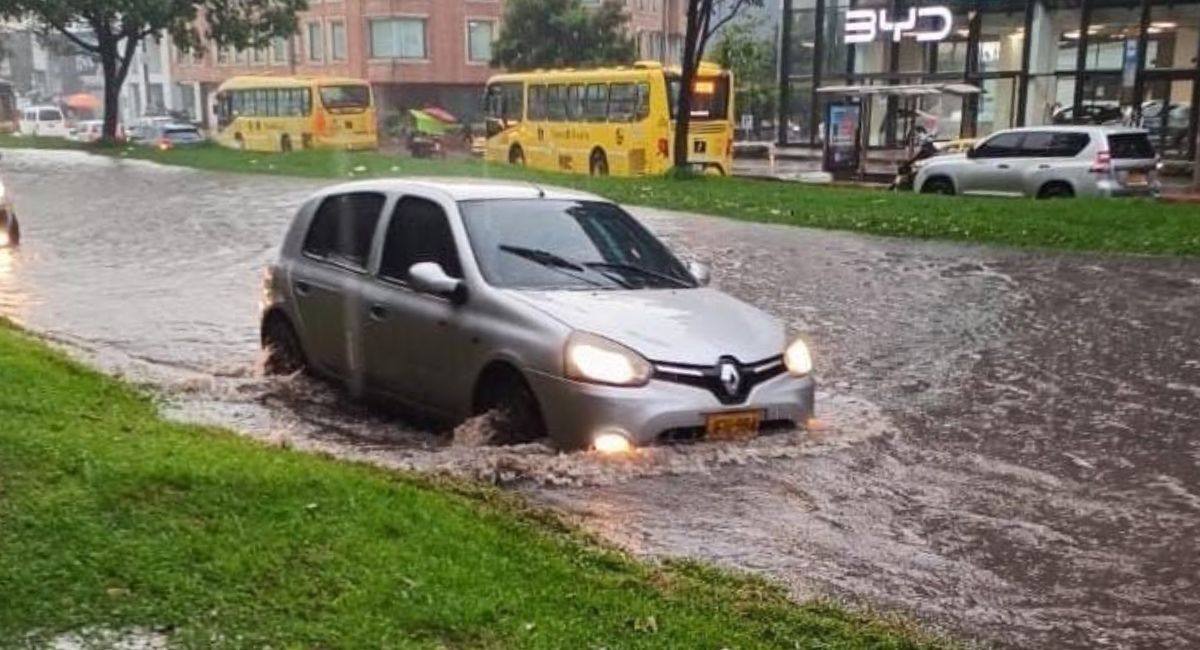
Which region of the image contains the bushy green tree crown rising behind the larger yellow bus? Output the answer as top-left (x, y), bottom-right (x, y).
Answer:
top-left (492, 0), bottom-right (637, 71)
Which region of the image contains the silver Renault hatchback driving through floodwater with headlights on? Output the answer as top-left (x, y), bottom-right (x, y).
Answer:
top-left (262, 180), bottom-right (815, 451)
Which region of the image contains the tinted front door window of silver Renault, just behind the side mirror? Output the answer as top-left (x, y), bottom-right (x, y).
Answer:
top-left (379, 197), bottom-right (462, 283)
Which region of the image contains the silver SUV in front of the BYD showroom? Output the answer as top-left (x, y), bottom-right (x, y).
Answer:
top-left (913, 126), bottom-right (1159, 199)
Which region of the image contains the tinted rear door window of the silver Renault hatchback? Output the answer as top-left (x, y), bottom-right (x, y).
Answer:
top-left (304, 192), bottom-right (384, 271)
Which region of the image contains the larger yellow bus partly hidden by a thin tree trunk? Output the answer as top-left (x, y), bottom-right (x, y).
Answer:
top-left (484, 61), bottom-right (733, 176)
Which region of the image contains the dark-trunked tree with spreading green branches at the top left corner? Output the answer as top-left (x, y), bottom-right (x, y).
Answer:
top-left (0, 0), bottom-right (307, 140)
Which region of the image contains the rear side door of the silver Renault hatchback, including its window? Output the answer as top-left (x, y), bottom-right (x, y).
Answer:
top-left (289, 192), bottom-right (385, 381)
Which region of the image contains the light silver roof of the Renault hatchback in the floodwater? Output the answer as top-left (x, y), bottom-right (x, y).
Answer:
top-left (319, 176), bottom-right (610, 203)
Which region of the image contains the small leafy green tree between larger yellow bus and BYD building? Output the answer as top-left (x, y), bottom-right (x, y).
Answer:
top-left (713, 18), bottom-right (779, 139)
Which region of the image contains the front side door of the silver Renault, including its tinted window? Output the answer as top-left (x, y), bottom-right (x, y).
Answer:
top-left (362, 195), bottom-right (469, 414)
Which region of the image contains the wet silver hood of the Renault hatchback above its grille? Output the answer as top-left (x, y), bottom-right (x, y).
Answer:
top-left (512, 288), bottom-right (787, 366)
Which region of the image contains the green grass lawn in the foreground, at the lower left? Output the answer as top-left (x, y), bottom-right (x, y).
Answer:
top-left (0, 321), bottom-right (947, 650)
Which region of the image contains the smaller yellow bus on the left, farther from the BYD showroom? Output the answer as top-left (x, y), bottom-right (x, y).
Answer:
top-left (214, 76), bottom-right (379, 151)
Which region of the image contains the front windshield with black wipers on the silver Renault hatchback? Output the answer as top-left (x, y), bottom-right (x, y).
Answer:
top-left (460, 199), bottom-right (696, 289)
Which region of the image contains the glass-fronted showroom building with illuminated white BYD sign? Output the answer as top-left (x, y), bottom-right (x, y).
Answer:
top-left (778, 0), bottom-right (1200, 160)
